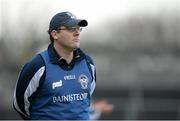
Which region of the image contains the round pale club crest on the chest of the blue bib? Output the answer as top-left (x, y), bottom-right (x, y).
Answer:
top-left (78, 74), bottom-right (89, 89)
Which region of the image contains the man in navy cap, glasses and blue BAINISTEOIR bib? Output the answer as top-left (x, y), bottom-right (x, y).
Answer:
top-left (13, 12), bottom-right (96, 120)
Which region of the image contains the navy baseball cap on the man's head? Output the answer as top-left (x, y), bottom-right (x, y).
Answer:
top-left (48, 11), bottom-right (88, 33)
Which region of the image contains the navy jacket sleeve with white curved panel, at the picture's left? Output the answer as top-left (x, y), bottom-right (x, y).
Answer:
top-left (13, 55), bottom-right (45, 119)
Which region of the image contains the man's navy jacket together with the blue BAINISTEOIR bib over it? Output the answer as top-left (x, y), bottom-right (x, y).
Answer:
top-left (13, 44), bottom-right (96, 120)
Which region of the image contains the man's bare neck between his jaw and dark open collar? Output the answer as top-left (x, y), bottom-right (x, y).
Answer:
top-left (54, 43), bottom-right (73, 64)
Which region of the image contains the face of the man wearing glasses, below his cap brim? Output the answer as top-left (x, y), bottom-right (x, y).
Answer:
top-left (54, 26), bottom-right (81, 51)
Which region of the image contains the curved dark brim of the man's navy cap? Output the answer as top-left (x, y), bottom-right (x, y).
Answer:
top-left (64, 19), bottom-right (88, 27)
